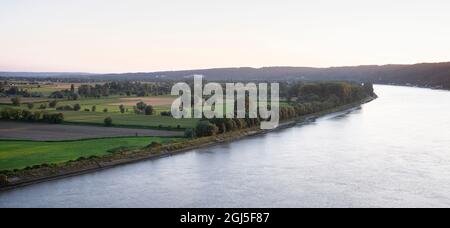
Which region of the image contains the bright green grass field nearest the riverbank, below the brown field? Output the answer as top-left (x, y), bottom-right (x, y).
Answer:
top-left (0, 137), bottom-right (183, 170)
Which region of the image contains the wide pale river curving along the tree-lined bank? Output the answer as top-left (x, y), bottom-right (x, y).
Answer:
top-left (0, 86), bottom-right (450, 207)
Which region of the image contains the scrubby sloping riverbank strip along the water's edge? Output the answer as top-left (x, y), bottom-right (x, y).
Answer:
top-left (0, 97), bottom-right (375, 191)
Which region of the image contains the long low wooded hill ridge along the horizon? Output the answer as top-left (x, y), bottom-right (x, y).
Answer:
top-left (0, 62), bottom-right (450, 89)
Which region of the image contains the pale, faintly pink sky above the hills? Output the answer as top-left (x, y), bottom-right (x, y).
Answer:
top-left (0, 0), bottom-right (450, 73)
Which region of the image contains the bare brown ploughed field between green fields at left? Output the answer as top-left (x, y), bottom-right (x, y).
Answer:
top-left (0, 121), bottom-right (184, 141)
